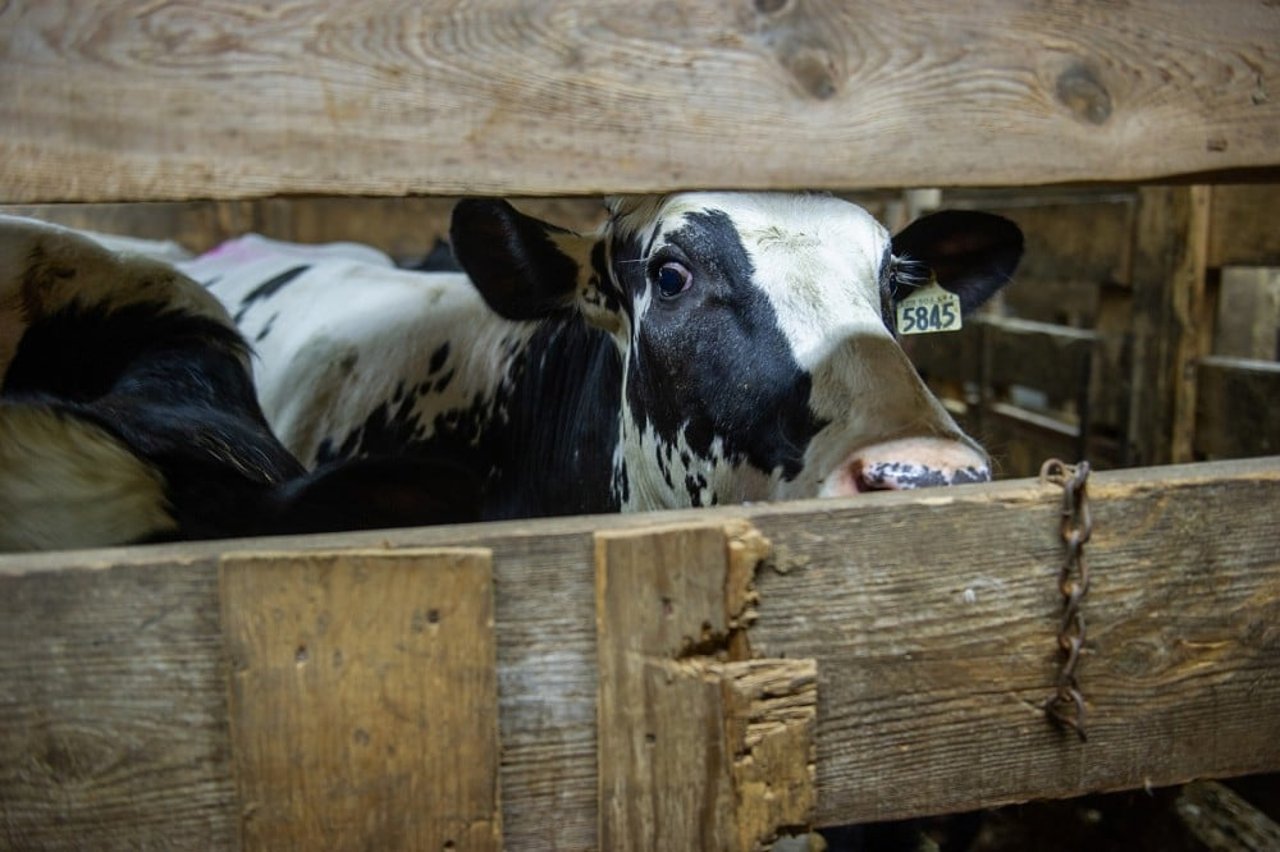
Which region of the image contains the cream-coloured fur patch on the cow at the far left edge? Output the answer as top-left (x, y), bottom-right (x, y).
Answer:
top-left (0, 403), bottom-right (177, 550)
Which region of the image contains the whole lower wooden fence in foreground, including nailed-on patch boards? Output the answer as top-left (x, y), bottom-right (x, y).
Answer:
top-left (0, 458), bottom-right (1280, 849)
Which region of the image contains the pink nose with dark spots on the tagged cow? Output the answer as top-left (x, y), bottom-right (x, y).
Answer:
top-left (819, 438), bottom-right (991, 496)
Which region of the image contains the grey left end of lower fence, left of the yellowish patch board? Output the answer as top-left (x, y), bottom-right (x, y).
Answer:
top-left (0, 556), bottom-right (238, 851)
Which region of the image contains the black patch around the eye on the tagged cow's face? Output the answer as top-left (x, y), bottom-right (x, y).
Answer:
top-left (614, 210), bottom-right (826, 483)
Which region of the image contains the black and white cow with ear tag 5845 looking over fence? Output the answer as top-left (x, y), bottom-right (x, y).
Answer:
top-left (197, 193), bottom-right (1023, 518)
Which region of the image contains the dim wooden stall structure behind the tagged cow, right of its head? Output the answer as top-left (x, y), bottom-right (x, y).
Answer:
top-left (913, 184), bottom-right (1280, 476)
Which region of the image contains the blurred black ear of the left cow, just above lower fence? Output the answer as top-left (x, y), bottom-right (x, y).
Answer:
top-left (264, 457), bottom-right (483, 535)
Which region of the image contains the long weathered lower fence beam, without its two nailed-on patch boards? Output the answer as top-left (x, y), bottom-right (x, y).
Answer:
top-left (0, 457), bottom-right (1280, 849)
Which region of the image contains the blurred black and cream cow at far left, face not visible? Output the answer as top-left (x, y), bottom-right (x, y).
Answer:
top-left (0, 216), bottom-right (479, 550)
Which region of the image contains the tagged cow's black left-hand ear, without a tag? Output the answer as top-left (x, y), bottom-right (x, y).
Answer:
top-left (449, 198), bottom-right (594, 320)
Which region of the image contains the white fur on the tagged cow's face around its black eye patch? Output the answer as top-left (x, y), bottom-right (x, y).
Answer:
top-left (611, 193), bottom-right (977, 508)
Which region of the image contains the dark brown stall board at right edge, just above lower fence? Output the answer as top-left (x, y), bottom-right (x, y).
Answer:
top-left (1196, 357), bottom-right (1280, 459)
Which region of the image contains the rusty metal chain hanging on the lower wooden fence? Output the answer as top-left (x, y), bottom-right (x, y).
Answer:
top-left (1041, 458), bottom-right (1093, 741)
